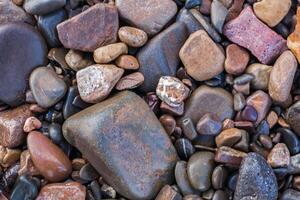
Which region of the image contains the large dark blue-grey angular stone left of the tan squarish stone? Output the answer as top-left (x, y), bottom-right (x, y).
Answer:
top-left (137, 22), bottom-right (188, 93)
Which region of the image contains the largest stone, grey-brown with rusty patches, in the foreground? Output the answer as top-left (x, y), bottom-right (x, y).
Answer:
top-left (63, 91), bottom-right (177, 199)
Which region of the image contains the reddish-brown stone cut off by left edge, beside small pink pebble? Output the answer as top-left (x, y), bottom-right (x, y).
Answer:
top-left (0, 105), bottom-right (33, 148)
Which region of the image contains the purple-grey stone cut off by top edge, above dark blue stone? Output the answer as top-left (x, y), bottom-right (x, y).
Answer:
top-left (23, 0), bottom-right (66, 15)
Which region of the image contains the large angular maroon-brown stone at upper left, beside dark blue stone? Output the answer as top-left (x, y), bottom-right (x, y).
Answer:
top-left (57, 3), bottom-right (119, 52)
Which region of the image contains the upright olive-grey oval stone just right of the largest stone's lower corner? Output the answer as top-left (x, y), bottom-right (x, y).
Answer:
top-left (187, 151), bottom-right (214, 192)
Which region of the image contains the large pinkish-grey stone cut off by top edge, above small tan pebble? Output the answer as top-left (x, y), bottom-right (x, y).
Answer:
top-left (116, 0), bottom-right (177, 35)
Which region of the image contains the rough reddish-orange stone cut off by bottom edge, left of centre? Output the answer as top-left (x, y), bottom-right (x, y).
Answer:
top-left (36, 182), bottom-right (86, 200)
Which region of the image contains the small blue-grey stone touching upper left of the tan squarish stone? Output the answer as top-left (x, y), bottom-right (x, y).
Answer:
top-left (176, 8), bottom-right (202, 34)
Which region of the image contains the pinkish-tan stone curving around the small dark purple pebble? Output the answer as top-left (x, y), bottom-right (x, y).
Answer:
top-left (246, 90), bottom-right (272, 126)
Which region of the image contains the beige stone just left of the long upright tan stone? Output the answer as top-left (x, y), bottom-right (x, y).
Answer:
top-left (246, 63), bottom-right (272, 91)
